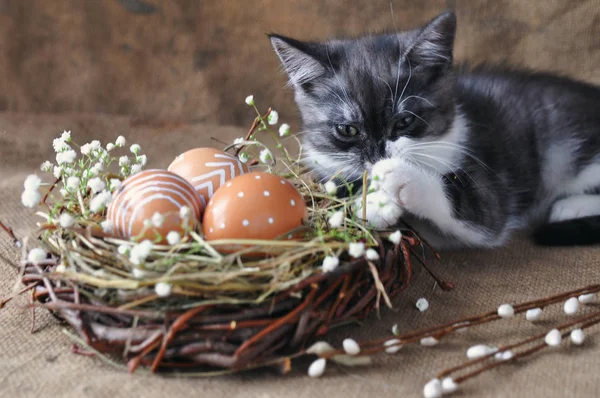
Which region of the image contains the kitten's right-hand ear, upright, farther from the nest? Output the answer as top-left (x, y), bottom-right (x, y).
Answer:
top-left (406, 12), bottom-right (456, 67)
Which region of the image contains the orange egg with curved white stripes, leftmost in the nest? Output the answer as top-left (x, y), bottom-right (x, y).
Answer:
top-left (107, 170), bottom-right (202, 244)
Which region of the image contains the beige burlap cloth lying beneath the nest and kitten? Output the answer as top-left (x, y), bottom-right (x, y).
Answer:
top-left (0, 113), bottom-right (600, 398)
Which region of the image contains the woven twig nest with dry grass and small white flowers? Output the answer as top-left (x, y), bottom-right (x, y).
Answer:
top-left (9, 103), bottom-right (440, 374)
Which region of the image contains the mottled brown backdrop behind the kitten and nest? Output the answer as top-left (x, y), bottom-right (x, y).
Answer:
top-left (0, 0), bottom-right (600, 125)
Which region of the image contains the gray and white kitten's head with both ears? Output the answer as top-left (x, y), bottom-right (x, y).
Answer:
top-left (271, 14), bottom-right (456, 185)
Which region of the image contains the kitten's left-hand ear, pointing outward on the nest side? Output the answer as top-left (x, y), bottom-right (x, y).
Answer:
top-left (269, 34), bottom-right (327, 88)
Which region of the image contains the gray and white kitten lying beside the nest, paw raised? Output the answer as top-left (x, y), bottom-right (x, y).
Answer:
top-left (270, 13), bottom-right (600, 247)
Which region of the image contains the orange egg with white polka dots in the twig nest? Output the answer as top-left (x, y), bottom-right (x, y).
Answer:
top-left (202, 172), bottom-right (307, 246)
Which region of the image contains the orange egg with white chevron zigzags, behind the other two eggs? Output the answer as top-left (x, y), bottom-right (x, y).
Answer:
top-left (168, 148), bottom-right (248, 210)
